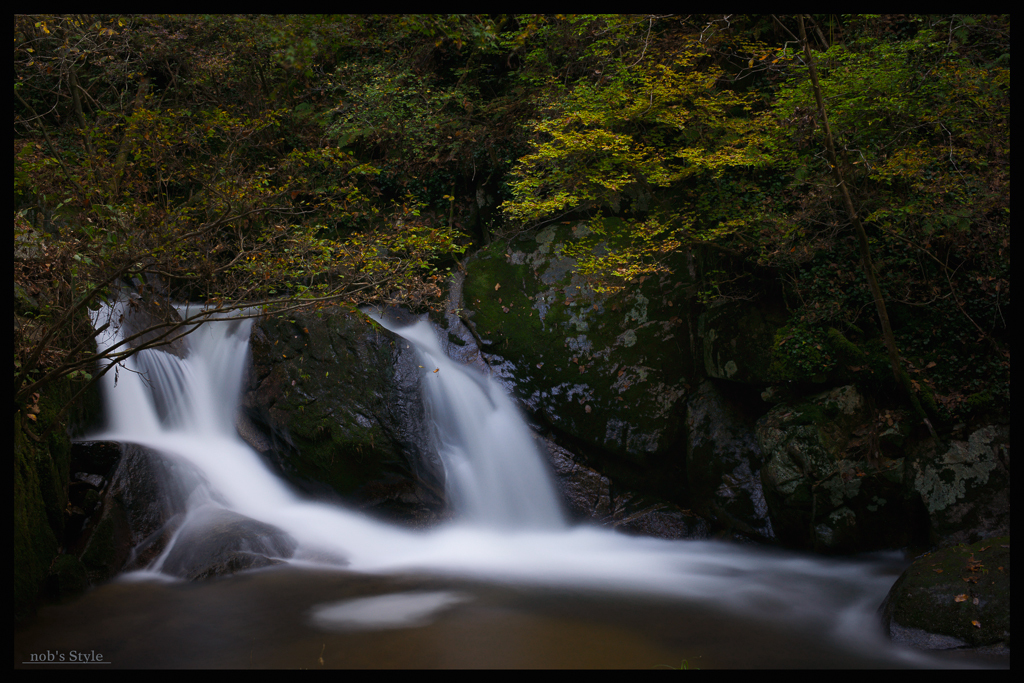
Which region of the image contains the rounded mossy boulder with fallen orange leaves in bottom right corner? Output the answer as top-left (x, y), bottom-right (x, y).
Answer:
top-left (882, 536), bottom-right (1010, 654)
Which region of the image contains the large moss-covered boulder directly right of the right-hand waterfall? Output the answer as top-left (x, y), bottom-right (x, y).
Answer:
top-left (463, 224), bottom-right (697, 496)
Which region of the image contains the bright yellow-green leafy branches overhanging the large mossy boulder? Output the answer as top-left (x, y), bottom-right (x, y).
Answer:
top-left (504, 26), bottom-right (774, 290)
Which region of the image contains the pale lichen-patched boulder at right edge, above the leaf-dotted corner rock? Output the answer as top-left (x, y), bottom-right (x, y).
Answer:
top-left (906, 425), bottom-right (1010, 546)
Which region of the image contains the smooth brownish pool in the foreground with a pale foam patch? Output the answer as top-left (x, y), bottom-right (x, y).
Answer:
top-left (14, 563), bottom-right (995, 669)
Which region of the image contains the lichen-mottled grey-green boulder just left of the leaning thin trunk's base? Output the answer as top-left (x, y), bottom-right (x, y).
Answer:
top-left (757, 386), bottom-right (927, 553)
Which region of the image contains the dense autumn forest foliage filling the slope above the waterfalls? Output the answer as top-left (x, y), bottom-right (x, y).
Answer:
top-left (13, 14), bottom-right (1010, 419)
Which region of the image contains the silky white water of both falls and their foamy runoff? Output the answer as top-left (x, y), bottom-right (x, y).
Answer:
top-left (86, 301), bottom-right (937, 661)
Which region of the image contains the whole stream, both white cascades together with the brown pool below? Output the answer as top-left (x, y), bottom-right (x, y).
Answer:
top-left (14, 305), bottom-right (983, 669)
